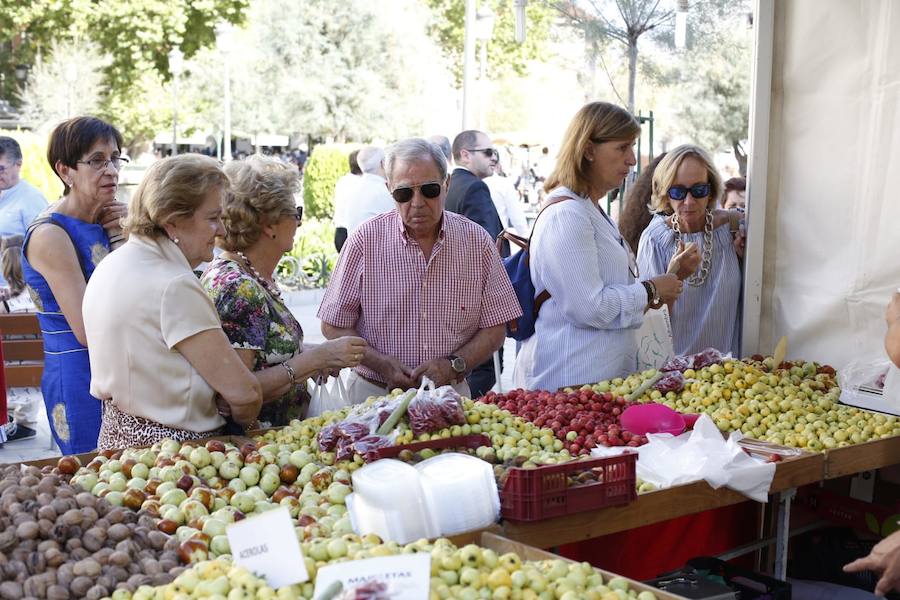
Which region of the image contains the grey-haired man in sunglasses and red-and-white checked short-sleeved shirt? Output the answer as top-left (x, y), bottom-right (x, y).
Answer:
top-left (318, 138), bottom-right (522, 403)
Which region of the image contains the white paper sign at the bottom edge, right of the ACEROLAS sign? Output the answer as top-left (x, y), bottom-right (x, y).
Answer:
top-left (314, 553), bottom-right (431, 600)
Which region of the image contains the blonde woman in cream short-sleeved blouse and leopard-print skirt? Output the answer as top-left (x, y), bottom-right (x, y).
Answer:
top-left (84, 154), bottom-right (264, 450)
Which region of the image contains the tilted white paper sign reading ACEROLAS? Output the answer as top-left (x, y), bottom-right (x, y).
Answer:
top-left (225, 508), bottom-right (309, 589)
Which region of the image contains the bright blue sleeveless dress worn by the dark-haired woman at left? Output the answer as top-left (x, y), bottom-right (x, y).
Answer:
top-left (22, 213), bottom-right (109, 454)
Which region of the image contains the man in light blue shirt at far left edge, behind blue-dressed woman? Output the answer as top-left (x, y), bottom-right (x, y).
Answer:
top-left (0, 136), bottom-right (47, 298)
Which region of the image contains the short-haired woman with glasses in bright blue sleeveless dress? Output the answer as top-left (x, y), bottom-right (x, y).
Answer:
top-left (22, 117), bottom-right (127, 454)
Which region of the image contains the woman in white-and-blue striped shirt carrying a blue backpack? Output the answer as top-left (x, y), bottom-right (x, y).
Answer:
top-left (515, 102), bottom-right (681, 390)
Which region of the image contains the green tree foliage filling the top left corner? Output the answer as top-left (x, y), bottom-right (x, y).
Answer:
top-left (0, 0), bottom-right (249, 148)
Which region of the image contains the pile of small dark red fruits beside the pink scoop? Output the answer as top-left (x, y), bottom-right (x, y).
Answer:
top-left (479, 388), bottom-right (647, 456)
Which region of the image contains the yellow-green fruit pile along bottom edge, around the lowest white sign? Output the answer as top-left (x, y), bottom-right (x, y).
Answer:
top-left (105, 534), bottom-right (655, 600)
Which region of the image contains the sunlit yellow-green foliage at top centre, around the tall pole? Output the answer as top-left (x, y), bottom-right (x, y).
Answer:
top-left (426, 0), bottom-right (556, 85)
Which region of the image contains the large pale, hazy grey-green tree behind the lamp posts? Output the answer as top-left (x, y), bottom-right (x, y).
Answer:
top-left (185, 0), bottom-right (450, 142)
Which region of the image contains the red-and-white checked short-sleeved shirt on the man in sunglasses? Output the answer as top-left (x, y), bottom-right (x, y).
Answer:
top-left (318, 209), bottom-right (522, 382)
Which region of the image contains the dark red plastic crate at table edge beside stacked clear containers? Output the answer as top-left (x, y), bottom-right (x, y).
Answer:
top-left (500, 452), bottom-right (637, 521)
